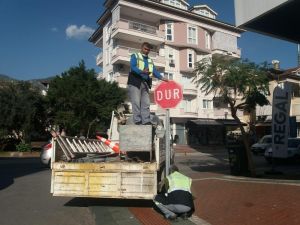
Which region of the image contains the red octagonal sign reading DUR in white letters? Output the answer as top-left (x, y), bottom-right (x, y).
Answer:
top-left (154, 81), bottom-right (182, 109)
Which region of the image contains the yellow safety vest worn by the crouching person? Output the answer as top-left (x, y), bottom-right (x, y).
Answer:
top-left (167, 171), bottom-right (192, 193)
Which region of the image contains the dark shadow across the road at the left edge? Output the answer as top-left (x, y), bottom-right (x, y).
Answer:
top-left (0, 158), bottom-right (46, 190)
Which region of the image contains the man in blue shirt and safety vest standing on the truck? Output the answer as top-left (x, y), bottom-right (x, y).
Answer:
top-left (127, 42), bottom-right (168, 125)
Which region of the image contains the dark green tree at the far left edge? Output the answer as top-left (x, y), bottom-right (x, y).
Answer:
top-left (0, 81), bottom-right (45, 143)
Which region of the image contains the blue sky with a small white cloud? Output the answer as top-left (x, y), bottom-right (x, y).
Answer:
top-left (0, 0), bottom-right (297, 80)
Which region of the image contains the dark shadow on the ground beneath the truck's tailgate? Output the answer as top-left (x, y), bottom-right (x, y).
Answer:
top-left (65, 198), bottom-right (153, 208)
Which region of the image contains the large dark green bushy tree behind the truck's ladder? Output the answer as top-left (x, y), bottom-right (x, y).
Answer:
top-left (47, 61), bottom-right (126, 135)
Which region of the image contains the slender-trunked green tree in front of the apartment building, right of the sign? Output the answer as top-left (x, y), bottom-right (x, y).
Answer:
top-left (194, 57), bottom-right (269, 176)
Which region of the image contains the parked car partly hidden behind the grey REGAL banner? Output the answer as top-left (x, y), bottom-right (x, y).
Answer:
top-left (264, 138), bottom-right (300, 163)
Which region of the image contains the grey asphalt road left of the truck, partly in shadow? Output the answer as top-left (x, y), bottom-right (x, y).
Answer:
top-left (0, 158), bottom-right (95, 225)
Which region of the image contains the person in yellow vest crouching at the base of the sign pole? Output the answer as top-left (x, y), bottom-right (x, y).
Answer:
top-left (153, 165), bottom-right (195, 220)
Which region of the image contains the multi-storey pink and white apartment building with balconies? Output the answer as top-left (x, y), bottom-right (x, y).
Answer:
top-left (89, 0), bottom-right (244, 144)
